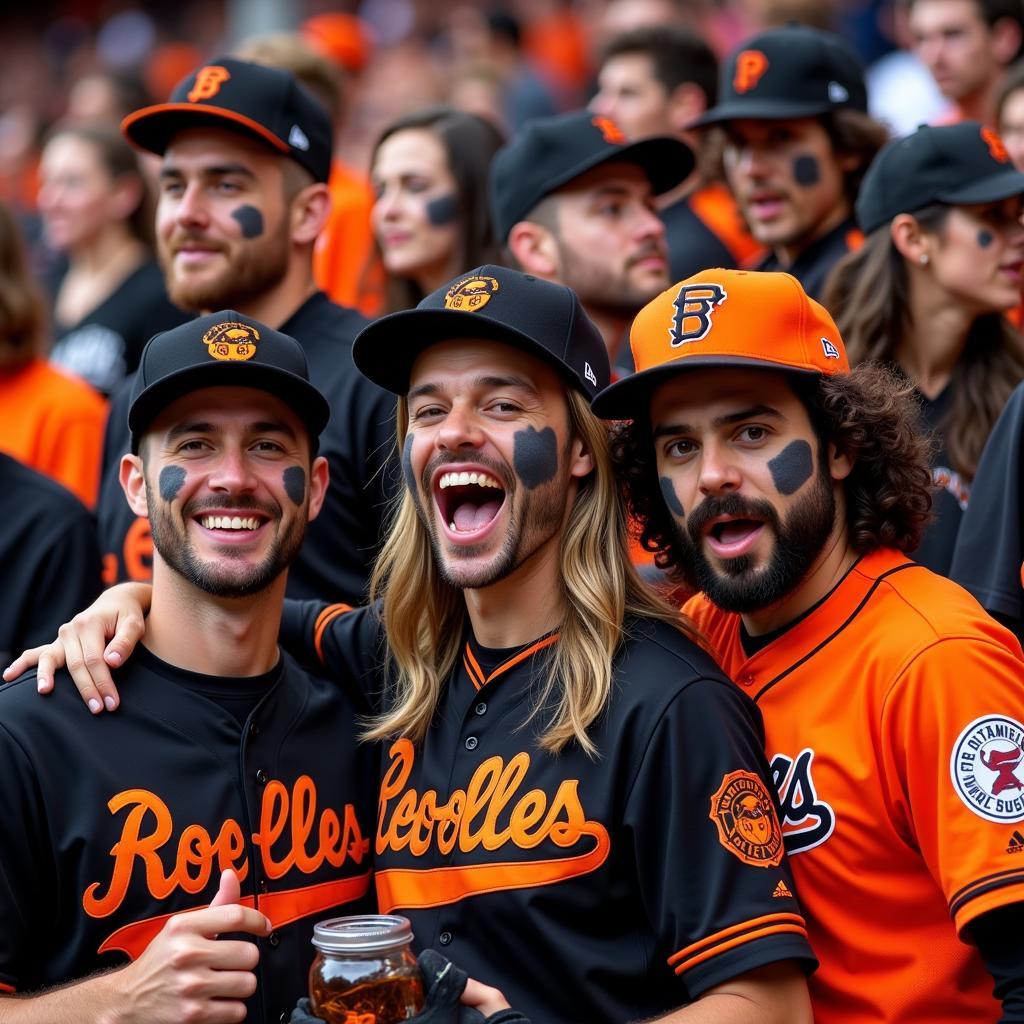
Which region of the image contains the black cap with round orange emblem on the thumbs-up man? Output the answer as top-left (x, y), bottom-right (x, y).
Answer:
top-left (128, 309), bottom-right (331, 453)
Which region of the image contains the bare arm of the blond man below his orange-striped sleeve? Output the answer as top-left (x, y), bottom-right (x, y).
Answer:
top-left (643, 963), bottom-right (814, 1024)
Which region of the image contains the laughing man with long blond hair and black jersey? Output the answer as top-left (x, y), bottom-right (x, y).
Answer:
top-left (6, 266), bottom-right (813, 1024)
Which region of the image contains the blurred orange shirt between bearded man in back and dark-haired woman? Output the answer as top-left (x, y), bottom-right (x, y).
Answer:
top-left (313, 160), bottom-right (384, 316)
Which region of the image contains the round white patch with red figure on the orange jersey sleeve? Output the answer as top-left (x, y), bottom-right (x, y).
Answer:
top-left (949, 715), bottom-right (1024, 822)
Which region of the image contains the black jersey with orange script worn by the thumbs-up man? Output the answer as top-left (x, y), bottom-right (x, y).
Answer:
top-left (0, 647), bottom-right (377, 1022)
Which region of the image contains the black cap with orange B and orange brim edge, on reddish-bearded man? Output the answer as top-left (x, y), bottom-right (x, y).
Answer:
top-left (121, 57), bottom-right (334, 181)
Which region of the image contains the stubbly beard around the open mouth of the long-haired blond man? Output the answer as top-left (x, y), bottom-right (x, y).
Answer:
top-left (413, 458), bottom-right (565, 590)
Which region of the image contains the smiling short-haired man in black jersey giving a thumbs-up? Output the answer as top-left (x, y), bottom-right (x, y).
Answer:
top-left (0, 311), bottom-right (376, 1024)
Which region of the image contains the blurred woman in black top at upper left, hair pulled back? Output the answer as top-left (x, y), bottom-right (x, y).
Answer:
top-left (39, 119), bottom-right (188, 394)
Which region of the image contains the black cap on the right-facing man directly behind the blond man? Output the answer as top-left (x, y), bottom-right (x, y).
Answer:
top-left (490, 111), bottom-right (694, 242)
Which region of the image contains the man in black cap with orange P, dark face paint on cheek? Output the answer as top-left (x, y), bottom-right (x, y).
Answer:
top-left (694, 26), bottom-right (886, 297)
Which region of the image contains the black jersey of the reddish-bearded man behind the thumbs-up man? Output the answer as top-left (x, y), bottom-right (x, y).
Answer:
top-left (97, 292), bottom-right (398, 602)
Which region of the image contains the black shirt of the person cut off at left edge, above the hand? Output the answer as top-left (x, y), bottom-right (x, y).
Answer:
top-left (0, 453), bottom-right (99, 665)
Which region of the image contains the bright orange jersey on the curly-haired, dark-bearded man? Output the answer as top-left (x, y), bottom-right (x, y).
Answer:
top-left (684, 549), bottom-right (1024, 1024)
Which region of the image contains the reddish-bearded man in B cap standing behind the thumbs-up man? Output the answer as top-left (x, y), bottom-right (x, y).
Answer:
top-left (98, 58), bottom-right (394, 601)
